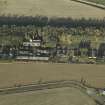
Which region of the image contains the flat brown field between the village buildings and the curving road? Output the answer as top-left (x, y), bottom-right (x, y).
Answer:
top-left (0, 63), bottom-right (105, 87)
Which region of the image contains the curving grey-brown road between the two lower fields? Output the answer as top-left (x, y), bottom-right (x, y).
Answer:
top-left (0, 80), bottom-right (98, 95)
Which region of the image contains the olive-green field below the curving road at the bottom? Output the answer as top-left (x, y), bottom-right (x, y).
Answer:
top-left (0, 88), bottom-right (96, 105)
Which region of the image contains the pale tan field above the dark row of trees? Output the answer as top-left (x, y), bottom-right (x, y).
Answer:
top-left (0, 0), bottom-right (105, 19)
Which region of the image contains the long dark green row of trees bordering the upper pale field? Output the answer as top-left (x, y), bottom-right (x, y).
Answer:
top-left (0, 15), bottom-right (105, 27)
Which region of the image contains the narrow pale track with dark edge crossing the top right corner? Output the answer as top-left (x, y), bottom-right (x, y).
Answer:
top-left (72, 0), bottom-right (105, 10)
